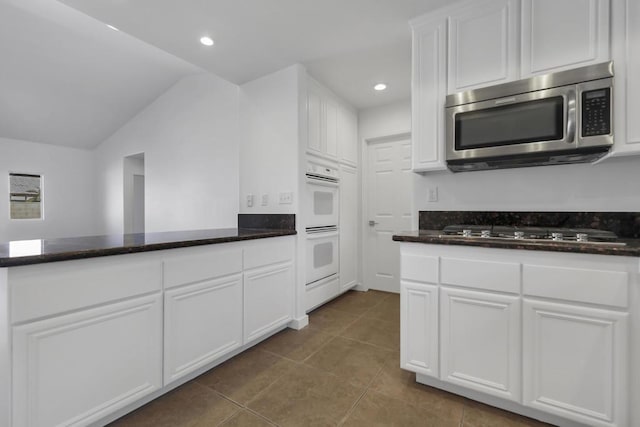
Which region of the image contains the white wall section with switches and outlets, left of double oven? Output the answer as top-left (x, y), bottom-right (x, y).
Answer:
top-left (240, 65), bottom-right (304, 213)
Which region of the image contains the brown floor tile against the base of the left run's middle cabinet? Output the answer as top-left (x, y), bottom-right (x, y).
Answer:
top-left (195, 348), bottom-right (296, 405)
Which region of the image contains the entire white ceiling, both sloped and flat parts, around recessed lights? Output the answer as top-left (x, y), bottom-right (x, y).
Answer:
top-left (0, 0), bottom-right (452, 148)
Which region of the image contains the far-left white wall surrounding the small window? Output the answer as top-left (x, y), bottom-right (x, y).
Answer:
top-left (0, 138), bottom-right (95, 242)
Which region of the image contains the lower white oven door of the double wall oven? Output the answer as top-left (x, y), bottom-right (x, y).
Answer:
top-left (305, 227), bottom-right (339, 285)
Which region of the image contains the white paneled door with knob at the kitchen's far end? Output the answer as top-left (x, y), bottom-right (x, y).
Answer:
top-left (364, 136), bottom-right (415, 293)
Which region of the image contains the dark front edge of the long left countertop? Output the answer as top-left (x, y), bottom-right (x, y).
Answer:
top-left (0, 229), bottom-right (297, 268)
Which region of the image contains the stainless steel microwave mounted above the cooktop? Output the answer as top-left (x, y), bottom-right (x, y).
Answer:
top-left (445, 62), bottom-right (613, 172)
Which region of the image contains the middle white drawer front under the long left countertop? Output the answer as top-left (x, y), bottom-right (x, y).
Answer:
top-left (164, 245), bottom-right (242, 288)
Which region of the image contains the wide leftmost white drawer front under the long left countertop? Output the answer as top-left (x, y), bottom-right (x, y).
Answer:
top-left (9, 254), bottom-right (162, 323)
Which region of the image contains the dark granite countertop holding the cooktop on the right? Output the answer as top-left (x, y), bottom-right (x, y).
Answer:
top-left (393, 230), bottom-right (640, 257)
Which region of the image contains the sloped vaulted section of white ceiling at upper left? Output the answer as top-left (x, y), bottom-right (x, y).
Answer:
top-left (0, 0), bottom-right (203, 148)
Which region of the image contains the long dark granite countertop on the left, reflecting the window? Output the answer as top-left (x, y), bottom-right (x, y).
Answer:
top-left (0, 228), bottom-right (296, 267)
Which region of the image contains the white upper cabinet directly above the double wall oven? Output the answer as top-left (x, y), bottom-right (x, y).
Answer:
top-left (307, 78), bottom-right (358, 166)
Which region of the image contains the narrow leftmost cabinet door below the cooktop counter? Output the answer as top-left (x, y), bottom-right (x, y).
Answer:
top-left (400, 280), bottom-right (438, 378)
